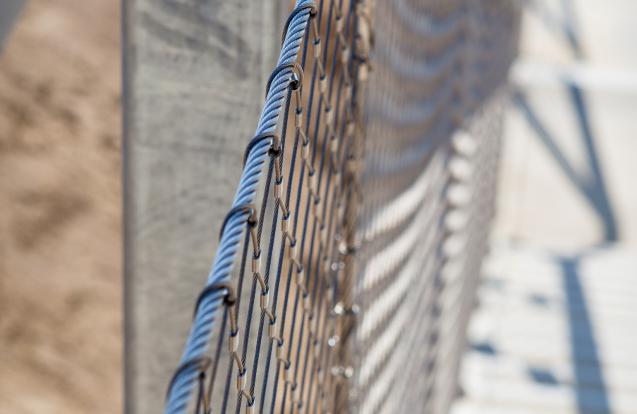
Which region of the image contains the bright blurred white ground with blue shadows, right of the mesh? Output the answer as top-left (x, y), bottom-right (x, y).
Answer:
top-left (454, 0), bottom-right (637, 414)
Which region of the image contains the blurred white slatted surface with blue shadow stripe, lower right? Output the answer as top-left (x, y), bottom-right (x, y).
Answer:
top-left (454, 246), bottom-right (637, 414)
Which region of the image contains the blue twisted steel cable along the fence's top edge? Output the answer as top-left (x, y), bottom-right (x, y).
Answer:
top-left (164, 0), bottom-right (312, 414)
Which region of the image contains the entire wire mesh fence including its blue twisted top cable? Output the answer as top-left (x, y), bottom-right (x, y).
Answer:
top-left (166, 0), bottom-right (518, 413)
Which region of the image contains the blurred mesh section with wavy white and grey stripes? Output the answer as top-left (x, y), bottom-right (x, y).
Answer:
top-left (349, 0), bottom-right (519, 413)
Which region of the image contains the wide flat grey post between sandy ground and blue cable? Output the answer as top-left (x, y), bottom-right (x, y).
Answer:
top-left (123, 0), bottom-right (287, 413)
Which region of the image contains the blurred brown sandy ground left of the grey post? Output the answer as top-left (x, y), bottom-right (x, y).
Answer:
top-left (0, 0), bottom-right (122, 413)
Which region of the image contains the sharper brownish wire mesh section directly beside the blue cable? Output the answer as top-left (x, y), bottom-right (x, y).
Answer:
top-left (171, 0), bottom-right (370, 413)
